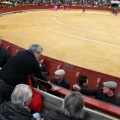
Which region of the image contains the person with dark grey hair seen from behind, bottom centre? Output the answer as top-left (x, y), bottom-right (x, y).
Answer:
top-left (44, 92), bottom-right (84, 120)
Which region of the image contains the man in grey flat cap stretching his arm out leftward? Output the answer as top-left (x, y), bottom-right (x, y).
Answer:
top-left (73, 81), bottom-right (120, 106)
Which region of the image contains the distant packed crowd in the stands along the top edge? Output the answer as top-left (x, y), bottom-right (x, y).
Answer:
top-left (0, 0), bottom-right (111, 7)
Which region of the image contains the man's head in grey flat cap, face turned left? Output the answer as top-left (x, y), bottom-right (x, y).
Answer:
top-left (103, 81), bottom-right (117, 96)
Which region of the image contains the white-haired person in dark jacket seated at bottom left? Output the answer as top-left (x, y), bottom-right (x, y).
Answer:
top-left (0, 84), bottom-right (42, 120)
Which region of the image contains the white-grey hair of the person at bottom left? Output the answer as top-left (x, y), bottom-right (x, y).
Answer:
top-left (11, 84), bottom-right (33, 108)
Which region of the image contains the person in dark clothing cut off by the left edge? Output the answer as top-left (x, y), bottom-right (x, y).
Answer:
top-left (0, 46), bottom-right (11, 68)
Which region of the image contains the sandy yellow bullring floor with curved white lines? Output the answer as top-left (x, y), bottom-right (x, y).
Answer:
top-left (0, 5), bottom-right (120, 77)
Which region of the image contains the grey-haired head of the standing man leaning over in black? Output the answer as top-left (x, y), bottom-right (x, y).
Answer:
top-left (28, 44), bottom-right (43, 60)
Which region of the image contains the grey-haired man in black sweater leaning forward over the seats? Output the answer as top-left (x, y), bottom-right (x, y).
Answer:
top-left (0, 44), bottom-right (52, 100)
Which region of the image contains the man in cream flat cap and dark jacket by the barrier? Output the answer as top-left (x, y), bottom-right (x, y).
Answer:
top-left (51, 69), bottom-right (70, 89)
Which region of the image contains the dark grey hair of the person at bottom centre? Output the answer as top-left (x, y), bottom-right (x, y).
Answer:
top-left (61, 92), bottom-right (84, 118)
